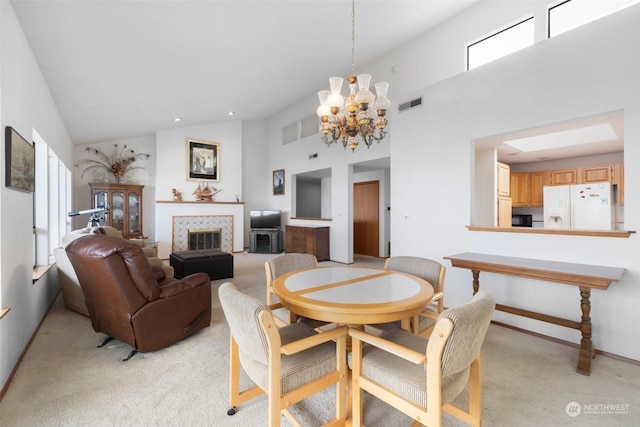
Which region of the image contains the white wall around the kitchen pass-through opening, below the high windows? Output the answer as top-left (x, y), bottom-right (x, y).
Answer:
top-left (391, 6), bottom-right (640, 360)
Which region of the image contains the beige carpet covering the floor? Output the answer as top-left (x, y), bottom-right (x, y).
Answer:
top-left (0, 253), bottom-right (640, 427)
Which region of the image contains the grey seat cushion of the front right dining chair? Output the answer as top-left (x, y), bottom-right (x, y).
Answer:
top-left (362, 329), bottom-right (469, 408)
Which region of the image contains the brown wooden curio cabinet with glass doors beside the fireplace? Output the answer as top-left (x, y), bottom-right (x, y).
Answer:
top-left (89, 183), bottom-right (144, 239)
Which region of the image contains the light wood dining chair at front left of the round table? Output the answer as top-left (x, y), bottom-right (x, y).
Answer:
top-left (218, 282), bottom-right (349, 427)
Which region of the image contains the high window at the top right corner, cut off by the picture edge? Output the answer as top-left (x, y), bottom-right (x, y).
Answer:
top-left (547, 0), bottom-right (640, 38)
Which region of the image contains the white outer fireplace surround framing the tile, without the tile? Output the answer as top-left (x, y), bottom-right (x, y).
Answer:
top-left (153, 200), bottom-right (244, 259)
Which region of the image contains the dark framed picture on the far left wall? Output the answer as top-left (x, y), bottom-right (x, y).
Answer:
top-left (4, 126), bottom-right (36, 193)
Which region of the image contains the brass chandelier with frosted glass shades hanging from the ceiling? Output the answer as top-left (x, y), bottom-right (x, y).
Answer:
top-left (317, 0), bottom-right (391, 151)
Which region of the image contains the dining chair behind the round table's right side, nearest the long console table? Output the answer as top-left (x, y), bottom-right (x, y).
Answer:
top-left (371, 256), bottom-right (446, 337)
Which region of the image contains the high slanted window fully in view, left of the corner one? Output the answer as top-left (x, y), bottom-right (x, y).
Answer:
top-left (467, 16), bottom-right (534, 70)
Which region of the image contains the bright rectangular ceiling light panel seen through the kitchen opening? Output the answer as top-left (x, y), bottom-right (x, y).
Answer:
top-left (504, 123), bottom-right (617, 152)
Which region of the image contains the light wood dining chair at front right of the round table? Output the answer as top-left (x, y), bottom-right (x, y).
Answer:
top-left (349, 291), bottom-right (495, 427)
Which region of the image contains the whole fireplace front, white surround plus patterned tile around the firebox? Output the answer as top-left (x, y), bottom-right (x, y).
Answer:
top-left (155, 201), bottom-right (244, 259)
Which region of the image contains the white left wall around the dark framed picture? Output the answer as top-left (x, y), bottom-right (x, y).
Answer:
top-left (0, 1), bottom-right (73, 392)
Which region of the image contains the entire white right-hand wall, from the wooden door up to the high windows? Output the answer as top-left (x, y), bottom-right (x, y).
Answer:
top-left (268, 1), bottom-right (640, 360)
